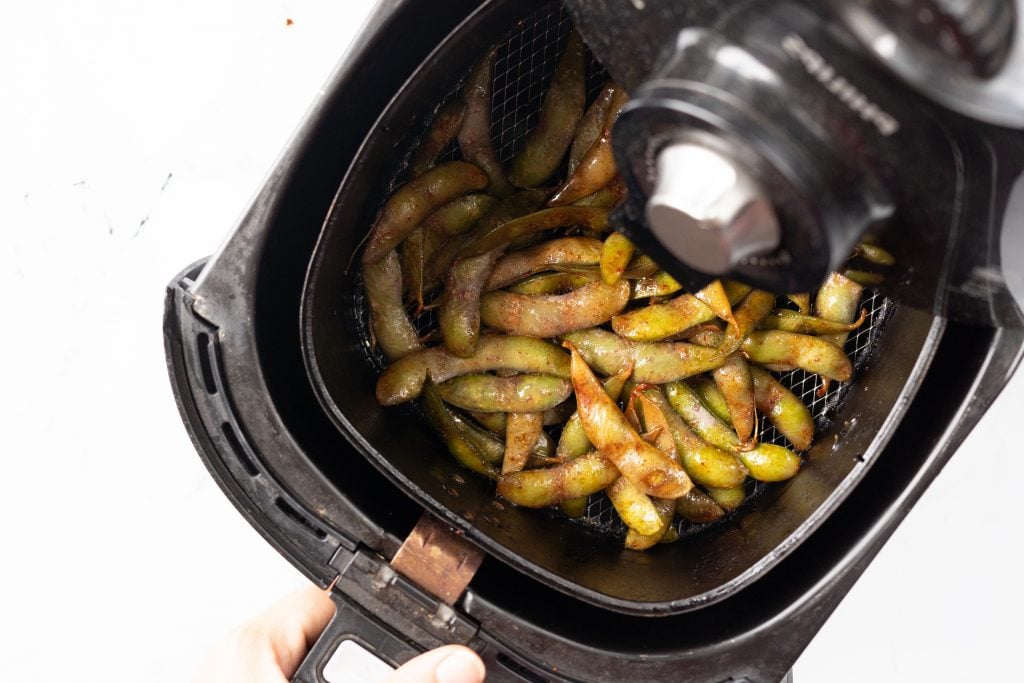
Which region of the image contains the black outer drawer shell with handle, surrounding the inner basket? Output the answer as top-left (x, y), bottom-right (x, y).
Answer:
top-left (164, 0), bottom-right (1024, 681)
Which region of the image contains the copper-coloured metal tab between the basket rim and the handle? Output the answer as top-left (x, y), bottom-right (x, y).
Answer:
top-left (391, 513), bottom-right (483, 605)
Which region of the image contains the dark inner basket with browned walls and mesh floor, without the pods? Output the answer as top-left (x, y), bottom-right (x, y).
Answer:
top-left (303, 2), bottom-right (932, 613)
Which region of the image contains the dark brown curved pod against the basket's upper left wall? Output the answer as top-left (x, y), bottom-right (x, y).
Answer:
top-left (362, 161), bottom-right (487, 265)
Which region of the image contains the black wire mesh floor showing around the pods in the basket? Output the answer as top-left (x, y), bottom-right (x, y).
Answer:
top-left (354, 2), bottom-right (891, 538)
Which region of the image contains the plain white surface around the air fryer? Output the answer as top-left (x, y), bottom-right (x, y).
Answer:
top-left (0, 0), bottom-right (1024, 683)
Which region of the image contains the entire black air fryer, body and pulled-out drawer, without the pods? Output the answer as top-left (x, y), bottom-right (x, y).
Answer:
top-left (165, 0), bottom-right (1024, 681)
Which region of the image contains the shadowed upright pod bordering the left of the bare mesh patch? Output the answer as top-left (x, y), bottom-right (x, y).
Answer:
top-left (459, 48), bottom-right (514, 198)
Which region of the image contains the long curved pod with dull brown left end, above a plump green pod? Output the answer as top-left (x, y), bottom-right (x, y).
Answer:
top-left (377, 335), bottom-right (569, 405)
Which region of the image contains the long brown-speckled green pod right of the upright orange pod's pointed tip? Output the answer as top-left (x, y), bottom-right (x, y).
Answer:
top-left (563, 328), bottom-right (725, 384)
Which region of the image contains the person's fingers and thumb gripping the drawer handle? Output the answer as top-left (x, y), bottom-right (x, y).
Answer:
top-left (196, 586), bottom-right (484, 683)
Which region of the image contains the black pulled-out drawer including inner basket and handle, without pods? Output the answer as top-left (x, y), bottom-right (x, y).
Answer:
top-left (165, 0), bottom-right (1024, 681)
